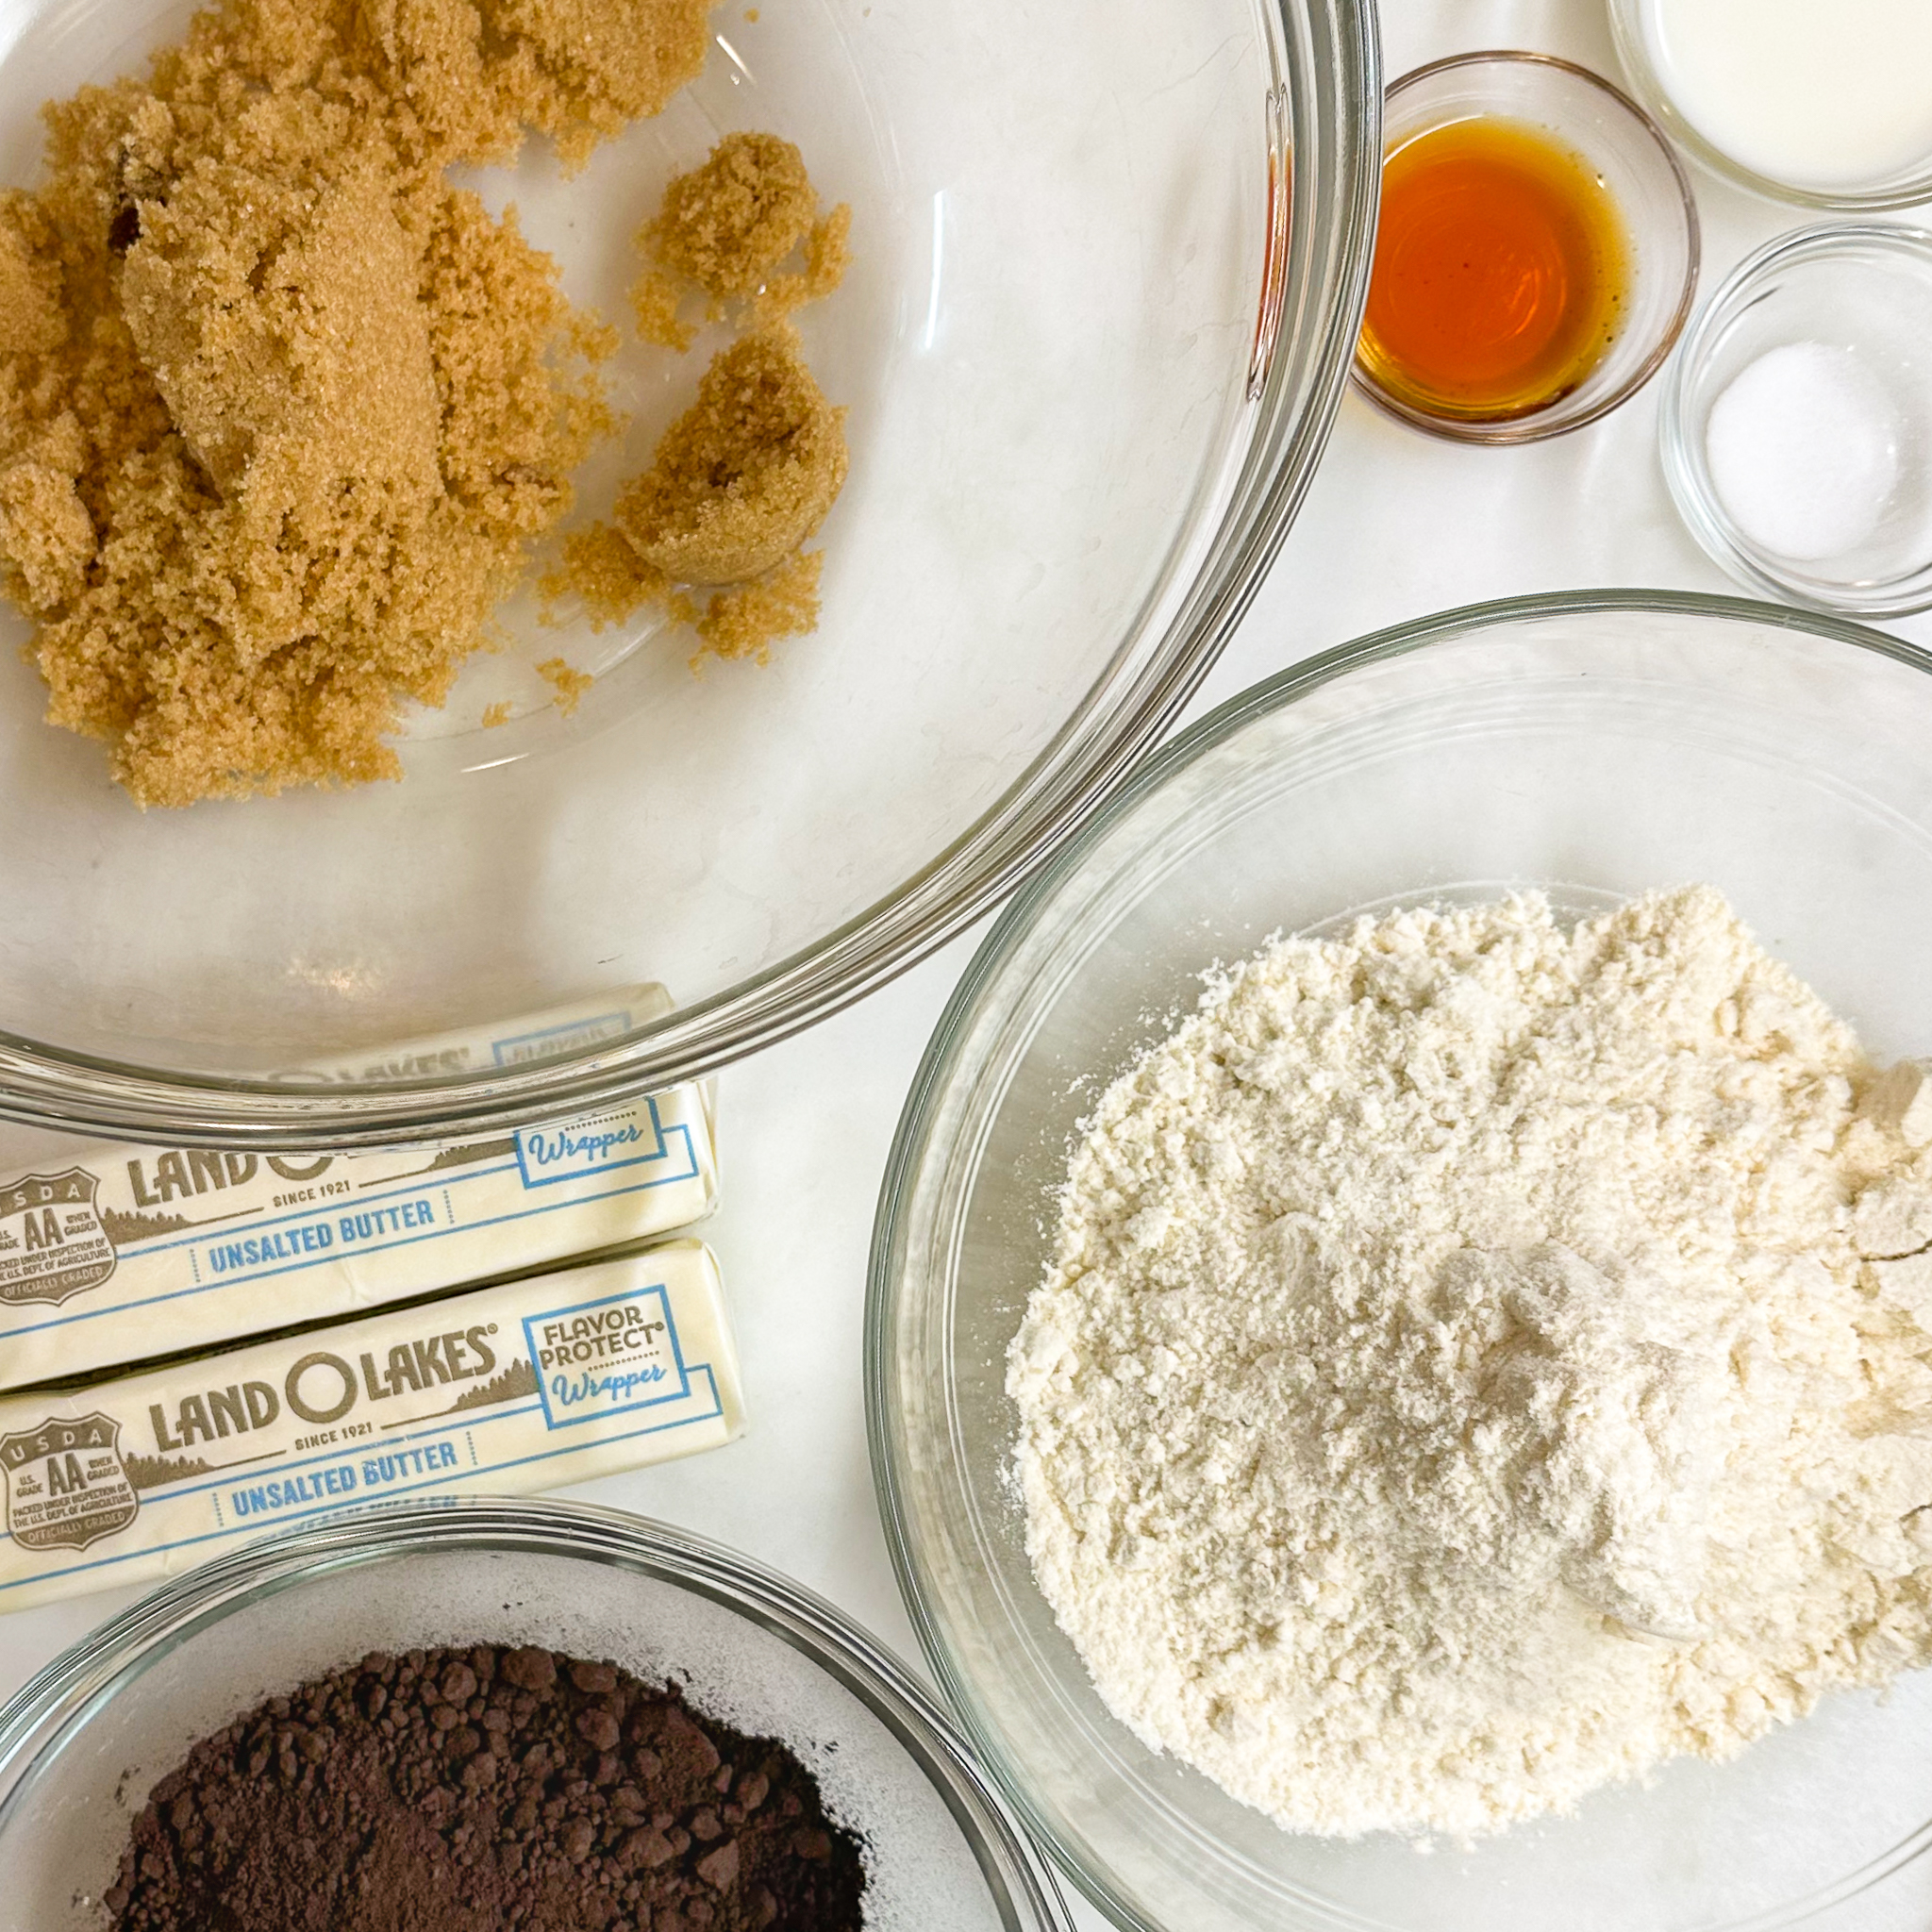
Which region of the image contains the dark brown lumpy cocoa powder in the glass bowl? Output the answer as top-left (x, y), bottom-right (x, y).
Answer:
top-left (105, 1644), bottom-right (863, 1932)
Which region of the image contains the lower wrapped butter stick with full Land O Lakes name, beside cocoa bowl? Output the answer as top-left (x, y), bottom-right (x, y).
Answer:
top-left (0, 1241), bottom-right (743, 1609)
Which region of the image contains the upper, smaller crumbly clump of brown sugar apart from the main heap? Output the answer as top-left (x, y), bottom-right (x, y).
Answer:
top-left (632, 133), bottom-right (852, 350)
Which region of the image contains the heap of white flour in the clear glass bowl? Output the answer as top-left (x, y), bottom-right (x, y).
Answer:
top-left (1008, 887), bottom-right (1932, 1836)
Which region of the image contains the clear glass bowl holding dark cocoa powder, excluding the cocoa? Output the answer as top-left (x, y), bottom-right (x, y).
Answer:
top-left (0, 1501), bottom-right (1071, 1932)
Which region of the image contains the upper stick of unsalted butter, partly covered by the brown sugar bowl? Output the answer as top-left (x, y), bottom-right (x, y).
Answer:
top-left (0, 1016), bottom-right (717, 1390)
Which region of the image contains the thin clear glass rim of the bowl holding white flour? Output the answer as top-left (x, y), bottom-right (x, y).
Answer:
top-left (863, 590), bottom-right (1932, 1932)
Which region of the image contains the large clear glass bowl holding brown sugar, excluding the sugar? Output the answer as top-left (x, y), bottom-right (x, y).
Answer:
top-left (0, 0), bottom-right (1379, 1145)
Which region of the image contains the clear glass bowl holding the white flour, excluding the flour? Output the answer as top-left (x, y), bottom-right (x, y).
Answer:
top-left (866, 591), bottom-right (1932, 1932)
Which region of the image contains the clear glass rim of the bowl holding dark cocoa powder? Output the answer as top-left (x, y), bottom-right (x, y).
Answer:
top-left (0, 1497), bottom-right (1074, 1932)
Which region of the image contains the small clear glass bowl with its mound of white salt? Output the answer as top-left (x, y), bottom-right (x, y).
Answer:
top-left (1661, 223), bottom-right (1932, 616)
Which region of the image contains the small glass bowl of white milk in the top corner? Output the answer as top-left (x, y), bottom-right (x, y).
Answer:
top-left (1609, 0), bottom-right (1932, 208)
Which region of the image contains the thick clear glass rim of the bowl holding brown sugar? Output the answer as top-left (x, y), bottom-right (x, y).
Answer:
top-left (0, 0), bottom-right (1381, 1152)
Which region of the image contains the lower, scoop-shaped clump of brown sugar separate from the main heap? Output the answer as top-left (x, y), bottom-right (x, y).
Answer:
top-left (616, 323), bottom-right (846, 583)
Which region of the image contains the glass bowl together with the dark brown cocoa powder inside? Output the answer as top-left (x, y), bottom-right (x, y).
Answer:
top-left (0, 1501), bottom-right (1069, 1932)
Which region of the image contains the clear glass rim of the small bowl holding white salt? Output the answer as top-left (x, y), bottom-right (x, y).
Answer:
top-left (1657, 220), bottom-right (1932, 618)
